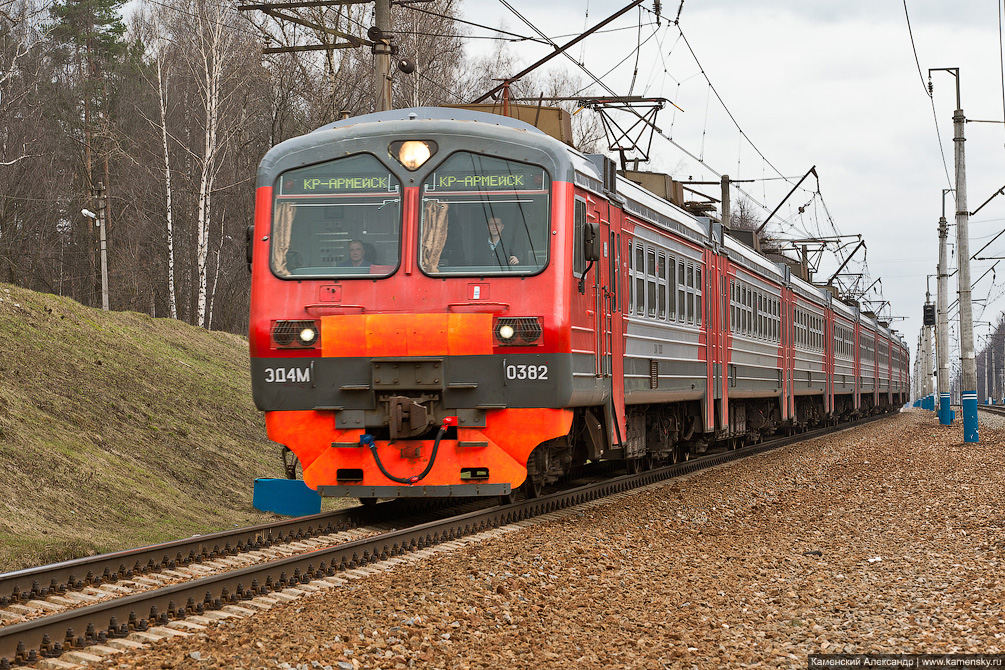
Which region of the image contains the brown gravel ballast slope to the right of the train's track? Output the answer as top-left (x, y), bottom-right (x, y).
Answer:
top-left (95, 410), bottom-right (1005, 670)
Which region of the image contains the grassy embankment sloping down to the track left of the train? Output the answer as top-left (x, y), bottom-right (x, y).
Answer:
top-left (0, 284), bottom-right (282, 572)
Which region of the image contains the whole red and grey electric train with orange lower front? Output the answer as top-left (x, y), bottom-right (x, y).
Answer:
top-left (249, 107), bottom-right (910, 499)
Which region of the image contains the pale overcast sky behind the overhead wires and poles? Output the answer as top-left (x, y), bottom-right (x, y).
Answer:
top-left (463, 0), bottom-right (1005, 371)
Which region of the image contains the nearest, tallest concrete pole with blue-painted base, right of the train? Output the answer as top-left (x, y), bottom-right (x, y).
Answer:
top-left (953, 104), bottom-right (979, 442)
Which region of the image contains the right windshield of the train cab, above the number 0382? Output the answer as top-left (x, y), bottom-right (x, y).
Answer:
top-left (419, 152), bottom-right (550, 275)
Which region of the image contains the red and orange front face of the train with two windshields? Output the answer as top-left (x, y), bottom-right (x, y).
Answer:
top-left (249, 110), bottom-right (594, 498)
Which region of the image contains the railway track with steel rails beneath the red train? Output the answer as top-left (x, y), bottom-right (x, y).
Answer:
top-left (0, 416), bottom-right (896, 670)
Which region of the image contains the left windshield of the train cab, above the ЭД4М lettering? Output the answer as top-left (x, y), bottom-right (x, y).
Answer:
top-left (270, 154), bottom-right (401, 278)
